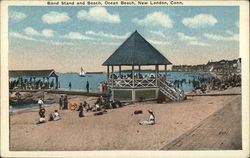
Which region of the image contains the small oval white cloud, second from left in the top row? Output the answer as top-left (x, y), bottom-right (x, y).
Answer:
top-left (42, 11), bottom-right (70, 24)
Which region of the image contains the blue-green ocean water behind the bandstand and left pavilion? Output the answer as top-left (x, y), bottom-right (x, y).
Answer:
top-left (9, 72), bottom-right (211, 111)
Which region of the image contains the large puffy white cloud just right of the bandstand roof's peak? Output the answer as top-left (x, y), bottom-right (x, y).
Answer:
top-left (132, 11), bottom-right (174, 28)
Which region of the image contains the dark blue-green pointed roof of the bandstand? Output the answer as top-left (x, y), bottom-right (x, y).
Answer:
top-left (103, 31), bottom-right (172, 65)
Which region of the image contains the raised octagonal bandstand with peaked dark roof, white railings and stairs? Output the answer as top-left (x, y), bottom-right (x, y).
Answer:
top-left (103, 31), bottom-right (184, 101)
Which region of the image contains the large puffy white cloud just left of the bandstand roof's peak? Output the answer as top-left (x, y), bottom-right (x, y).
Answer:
top-left (76, 7), bottom-right (121, 23)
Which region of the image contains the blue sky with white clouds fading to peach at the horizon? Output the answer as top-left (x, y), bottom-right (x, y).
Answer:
top-left (8, 6), bottom-right (239, 72)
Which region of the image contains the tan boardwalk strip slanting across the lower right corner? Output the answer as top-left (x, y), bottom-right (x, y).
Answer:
top-left (161, 96), bottom-right (242, 150)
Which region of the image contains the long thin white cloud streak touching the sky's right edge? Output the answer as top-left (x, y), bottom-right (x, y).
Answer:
top-left (203, 33), bottom-right (239, 41)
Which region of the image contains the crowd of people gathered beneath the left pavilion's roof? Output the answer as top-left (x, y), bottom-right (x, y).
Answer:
top-left (9, 77), bottom-right (56, 89)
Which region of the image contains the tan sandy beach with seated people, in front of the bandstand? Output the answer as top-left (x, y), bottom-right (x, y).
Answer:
top-left (10, 87), bottom-right (241, 151)
